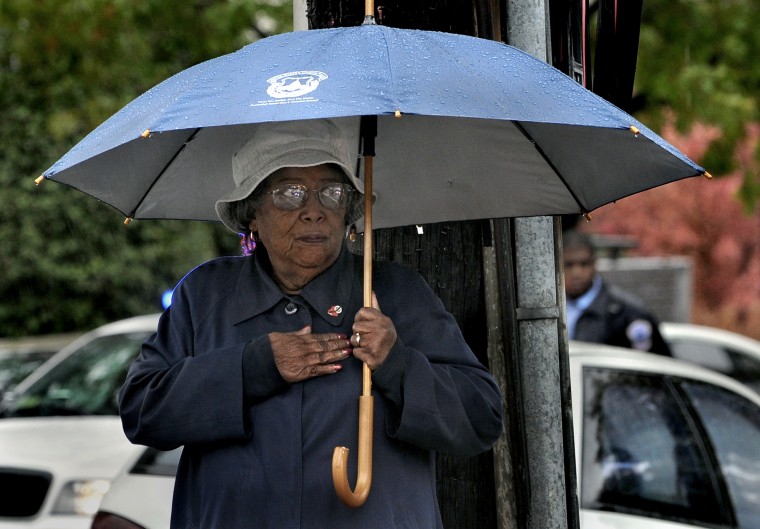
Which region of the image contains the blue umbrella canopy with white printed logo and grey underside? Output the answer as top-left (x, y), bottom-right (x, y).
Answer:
top-left (42, 25), bottom-right (704, 228)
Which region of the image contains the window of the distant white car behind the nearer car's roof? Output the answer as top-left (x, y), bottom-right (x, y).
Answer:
top-left (670, 339), bottom-right (760, 392)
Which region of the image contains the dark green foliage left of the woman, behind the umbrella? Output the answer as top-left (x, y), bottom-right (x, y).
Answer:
top-left (0, 0), bottom-right (292, 336)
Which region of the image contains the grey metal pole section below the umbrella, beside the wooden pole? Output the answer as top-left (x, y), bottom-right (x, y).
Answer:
top-left (513, 217), bottom-right (568, 529)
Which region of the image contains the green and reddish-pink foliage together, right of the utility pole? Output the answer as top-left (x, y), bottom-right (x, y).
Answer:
top-left (583, 0), bottom-right (760, 338)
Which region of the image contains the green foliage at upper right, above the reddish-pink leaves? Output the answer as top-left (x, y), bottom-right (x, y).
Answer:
top-left (636, 0), bottom-right (760, 194)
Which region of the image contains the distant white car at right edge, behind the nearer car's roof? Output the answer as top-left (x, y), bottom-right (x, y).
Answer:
top-left (660, 323), bottom-right (760, 393)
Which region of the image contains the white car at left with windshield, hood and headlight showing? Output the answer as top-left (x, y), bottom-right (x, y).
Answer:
top-left (0, 315), bottom-right (158, 529)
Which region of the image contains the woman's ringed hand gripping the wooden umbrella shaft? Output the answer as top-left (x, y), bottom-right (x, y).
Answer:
top-left (351, 292), bottom-right (397, 371)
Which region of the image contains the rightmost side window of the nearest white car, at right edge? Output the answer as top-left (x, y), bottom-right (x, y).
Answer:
top-left (684, 383), bottom-right (760, 529)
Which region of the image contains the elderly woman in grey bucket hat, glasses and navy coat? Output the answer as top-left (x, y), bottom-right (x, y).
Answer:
top-left (119, 120), bottom-right (502, 529)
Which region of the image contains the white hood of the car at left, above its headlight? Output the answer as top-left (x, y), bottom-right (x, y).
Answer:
top-left (0, 416), bottom-right (144, 479)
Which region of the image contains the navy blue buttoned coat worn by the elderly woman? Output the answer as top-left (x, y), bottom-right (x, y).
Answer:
top-left (120, 248), bottom-right (503, 529)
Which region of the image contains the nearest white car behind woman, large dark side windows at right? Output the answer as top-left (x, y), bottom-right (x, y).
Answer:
top-left (92, 342), bottom-right (760, 529)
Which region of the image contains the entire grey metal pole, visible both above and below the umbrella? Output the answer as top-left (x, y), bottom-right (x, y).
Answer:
top-left (494, 0), bottom-right (579, 529)
